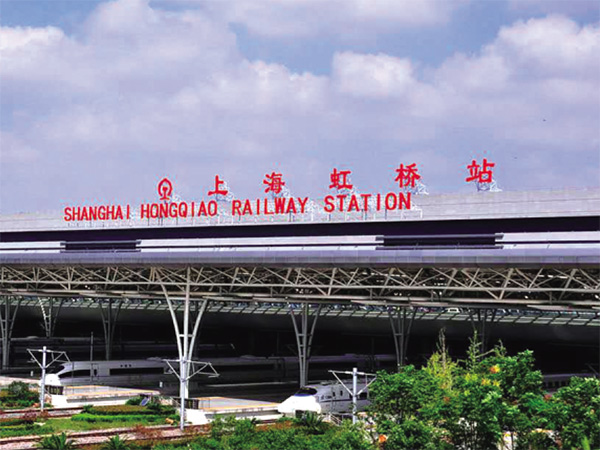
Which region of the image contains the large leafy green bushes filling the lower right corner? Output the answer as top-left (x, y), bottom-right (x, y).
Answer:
top-left (371, 337), bottom-right (600, 450)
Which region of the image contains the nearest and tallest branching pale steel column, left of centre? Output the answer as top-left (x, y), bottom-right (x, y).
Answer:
top-left (157, 268), bottom-right (208, 430)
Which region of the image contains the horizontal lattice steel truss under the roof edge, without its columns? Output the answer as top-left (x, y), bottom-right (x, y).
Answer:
top-left (0, 266), bottom-right (600, 309)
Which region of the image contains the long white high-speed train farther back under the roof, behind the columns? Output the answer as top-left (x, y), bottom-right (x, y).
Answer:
top-left (46, 354), bottom-right (395, 387)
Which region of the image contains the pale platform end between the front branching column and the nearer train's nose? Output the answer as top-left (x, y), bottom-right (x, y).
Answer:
top-left (186, 397), bottom-right (281, 425)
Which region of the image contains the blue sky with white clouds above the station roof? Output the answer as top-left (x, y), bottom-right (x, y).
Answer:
top-left (0, 0), bottom-right (600, 214)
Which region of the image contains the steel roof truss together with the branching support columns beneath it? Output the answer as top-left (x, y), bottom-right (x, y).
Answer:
top-left (0, 262), bottom-right (600, 396)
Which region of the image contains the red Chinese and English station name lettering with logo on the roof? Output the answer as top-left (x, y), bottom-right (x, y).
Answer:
top-left (63, 159), bottom-right (494, 222)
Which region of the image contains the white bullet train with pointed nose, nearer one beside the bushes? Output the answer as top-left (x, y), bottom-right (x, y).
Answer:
top-left (277, 382), bottom-right (370, 416)
